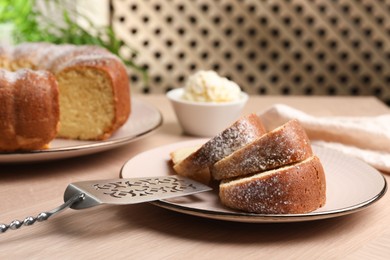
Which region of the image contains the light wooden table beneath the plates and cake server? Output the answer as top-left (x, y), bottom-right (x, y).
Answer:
top-left (0, 96), bottom-right (390, 259)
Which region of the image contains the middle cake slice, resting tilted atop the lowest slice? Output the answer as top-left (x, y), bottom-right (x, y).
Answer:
top-left (210, 120), bottom-right (313, 180)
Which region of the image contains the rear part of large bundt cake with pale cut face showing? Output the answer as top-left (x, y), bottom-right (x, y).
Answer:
top-left (0, 43), bottom-right (131, 150)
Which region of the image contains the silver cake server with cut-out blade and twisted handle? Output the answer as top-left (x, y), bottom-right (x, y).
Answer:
top-left (0, 175), bottom-right (211, 233)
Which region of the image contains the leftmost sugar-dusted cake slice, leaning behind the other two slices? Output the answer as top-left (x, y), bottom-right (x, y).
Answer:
top-left (171, 114), bottom-right (265, 183)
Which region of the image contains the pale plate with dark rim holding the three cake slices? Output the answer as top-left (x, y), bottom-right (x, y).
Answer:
top-left (121, 139), bottom-right (387, 223)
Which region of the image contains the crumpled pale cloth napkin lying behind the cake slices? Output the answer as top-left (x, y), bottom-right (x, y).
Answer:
top-left (258, 104), bottom-right (390, 172)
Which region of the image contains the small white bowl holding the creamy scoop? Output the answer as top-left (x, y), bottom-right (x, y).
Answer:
top-left (166, 88), bottom-right (248, 137)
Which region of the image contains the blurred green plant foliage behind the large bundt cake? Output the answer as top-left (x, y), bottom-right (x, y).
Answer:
top-left (0, 0), bottom-right (148, 81)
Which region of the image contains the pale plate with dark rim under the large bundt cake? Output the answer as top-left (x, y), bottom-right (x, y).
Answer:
top-left (0, 98), bottom-right (163, 163)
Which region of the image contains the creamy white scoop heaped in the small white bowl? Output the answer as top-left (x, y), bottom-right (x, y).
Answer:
top-left (183, 70), bottom-right (241, 103)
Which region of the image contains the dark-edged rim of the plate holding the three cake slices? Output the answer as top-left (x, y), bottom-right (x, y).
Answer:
top-left (120, 138), bottom-right (388, 223)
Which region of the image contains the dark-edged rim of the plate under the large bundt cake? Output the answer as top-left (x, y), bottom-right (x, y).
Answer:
top-left (0, 98), bottom-right (164, 164)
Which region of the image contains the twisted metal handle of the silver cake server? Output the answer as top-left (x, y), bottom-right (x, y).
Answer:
top-left (0, 193), bottom-right (85, 233)
